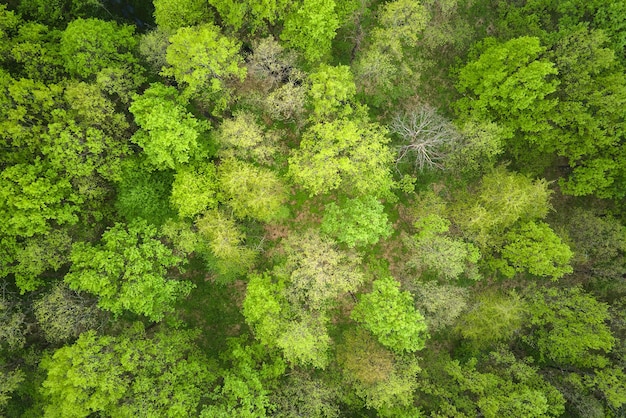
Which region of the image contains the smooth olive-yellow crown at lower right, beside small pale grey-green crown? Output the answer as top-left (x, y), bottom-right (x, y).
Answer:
top-left (457, 292), bottom-right (526, 347)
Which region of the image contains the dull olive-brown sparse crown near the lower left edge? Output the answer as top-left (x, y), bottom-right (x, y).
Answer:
top-left (33, 283), bottom-right (103, 344)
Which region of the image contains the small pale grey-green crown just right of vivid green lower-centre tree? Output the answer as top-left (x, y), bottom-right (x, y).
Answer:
top-left (413, 281), bottom-right (469, 332)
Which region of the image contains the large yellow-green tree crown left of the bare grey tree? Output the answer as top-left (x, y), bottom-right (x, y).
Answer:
top-left (289, 119), bottom-right (393, 196)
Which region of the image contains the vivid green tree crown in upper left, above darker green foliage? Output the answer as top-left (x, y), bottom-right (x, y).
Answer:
top-left (129, 83), bottom-right (205, 169)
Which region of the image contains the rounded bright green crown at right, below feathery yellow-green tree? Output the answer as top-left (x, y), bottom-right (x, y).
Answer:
top-left (501, 221), bottom-right (573, 280)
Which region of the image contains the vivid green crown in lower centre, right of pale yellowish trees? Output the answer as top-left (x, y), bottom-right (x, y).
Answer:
top-left (350, 277), bottom-right (428, 353)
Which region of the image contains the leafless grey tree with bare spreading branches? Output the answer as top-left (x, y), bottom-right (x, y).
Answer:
top-left (389, 105), bottom-right (461, 171)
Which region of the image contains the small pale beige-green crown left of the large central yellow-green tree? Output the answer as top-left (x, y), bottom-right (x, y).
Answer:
top-left (217, 112), bottom-right (277, 164)
